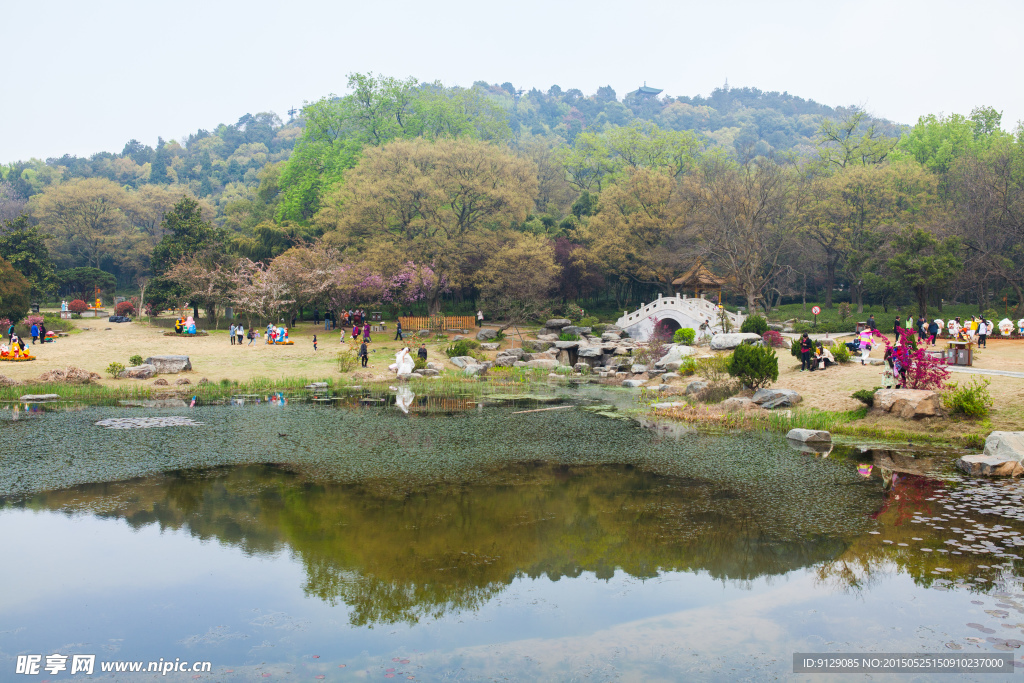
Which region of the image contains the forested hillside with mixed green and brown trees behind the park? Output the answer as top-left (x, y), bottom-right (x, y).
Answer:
top-left (0, 74), bottom-right (1024, 325)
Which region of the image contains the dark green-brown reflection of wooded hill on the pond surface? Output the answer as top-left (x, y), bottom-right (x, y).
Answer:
top-left (9, 463), bottom-right (867, 625)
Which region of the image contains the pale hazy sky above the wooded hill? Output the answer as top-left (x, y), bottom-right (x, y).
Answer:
top-left (0, 0), bottom-right (1024, 163)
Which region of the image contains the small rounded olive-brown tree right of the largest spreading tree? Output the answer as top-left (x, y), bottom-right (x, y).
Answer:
top-left (476, 232), bottom-right (560, 330)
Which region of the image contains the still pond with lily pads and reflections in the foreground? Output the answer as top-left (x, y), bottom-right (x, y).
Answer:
top-left (0, 397), bottom-right (1024, 681)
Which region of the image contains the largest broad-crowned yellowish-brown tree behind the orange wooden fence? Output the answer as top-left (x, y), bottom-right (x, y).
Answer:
top-left (316, 138), bottom-right (537, 313)
